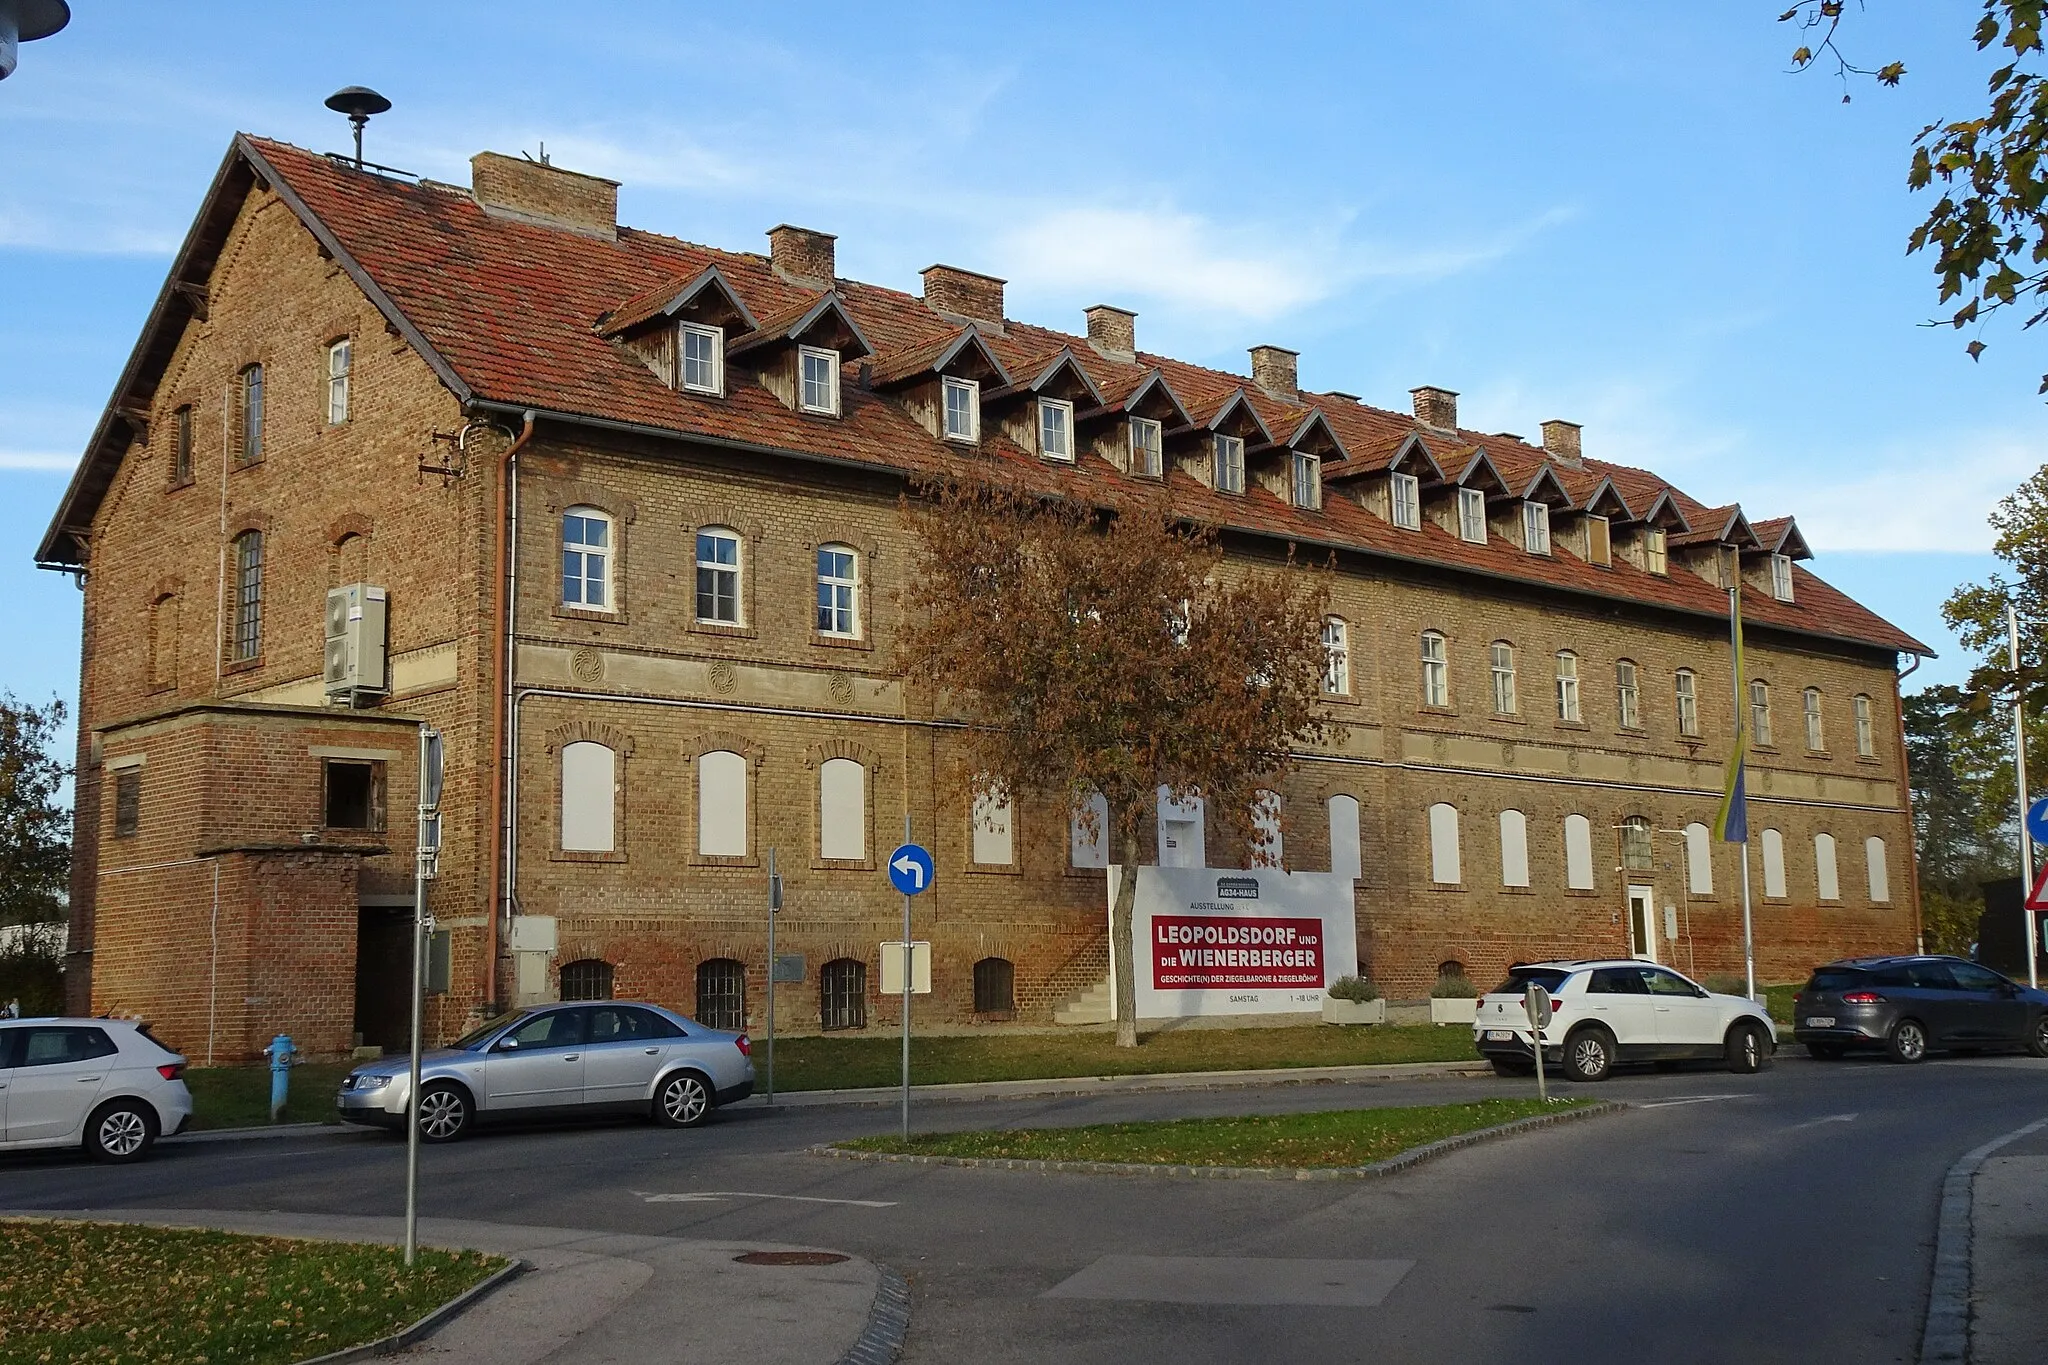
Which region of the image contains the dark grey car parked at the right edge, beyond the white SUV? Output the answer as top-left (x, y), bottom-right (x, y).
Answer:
top-left (1792, 956), bottom-right (2048, 1062)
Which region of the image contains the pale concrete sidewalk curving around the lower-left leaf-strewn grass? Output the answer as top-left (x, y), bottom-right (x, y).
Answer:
top-left (2, 1209), bottom-right (909, 1365)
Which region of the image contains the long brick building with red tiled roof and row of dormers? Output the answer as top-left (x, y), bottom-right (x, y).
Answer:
top-left (39, 137), bottom-right (1927, 1060)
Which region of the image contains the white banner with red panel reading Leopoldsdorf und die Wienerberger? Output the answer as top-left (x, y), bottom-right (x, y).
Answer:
top-left (1110, 868), bottom-right (1358, 1019)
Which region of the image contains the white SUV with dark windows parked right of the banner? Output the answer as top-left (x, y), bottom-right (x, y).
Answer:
top-left (1473, 958), bottom-right (1778, 1081)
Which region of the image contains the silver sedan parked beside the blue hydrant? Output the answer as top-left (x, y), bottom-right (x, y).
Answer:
top-left (336, 1001), bottom-right (754, 1142)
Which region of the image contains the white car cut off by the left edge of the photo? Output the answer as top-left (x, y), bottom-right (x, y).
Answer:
top-left (0, 1019), bottom-right (193, 1160)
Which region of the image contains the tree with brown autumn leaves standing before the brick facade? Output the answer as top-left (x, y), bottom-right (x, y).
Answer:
top-left (899, 481), bottom-right (1339, 1048)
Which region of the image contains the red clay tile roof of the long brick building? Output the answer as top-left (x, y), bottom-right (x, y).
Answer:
top-left (43, 135), bottom-right (1931, 655)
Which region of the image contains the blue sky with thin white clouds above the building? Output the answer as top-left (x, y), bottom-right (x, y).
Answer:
top-left (0, 0), bottom-right (2048, 736)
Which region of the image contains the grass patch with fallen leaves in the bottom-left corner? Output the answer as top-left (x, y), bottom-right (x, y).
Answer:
top-left (0, 1220), bottom-right (506, 1365)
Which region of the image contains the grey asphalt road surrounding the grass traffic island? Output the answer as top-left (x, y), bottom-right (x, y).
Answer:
top-left (0, 1056), bottom-right (2048, 1365)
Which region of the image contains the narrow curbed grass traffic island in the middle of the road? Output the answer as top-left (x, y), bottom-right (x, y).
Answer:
top-left (838, 1097), bottom-right (1593, 1171)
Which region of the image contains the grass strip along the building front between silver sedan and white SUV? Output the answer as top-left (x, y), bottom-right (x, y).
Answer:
top-left (754, 1025), bottom-right (1479, 1091)
